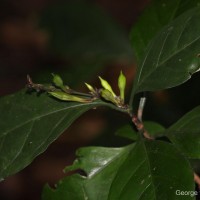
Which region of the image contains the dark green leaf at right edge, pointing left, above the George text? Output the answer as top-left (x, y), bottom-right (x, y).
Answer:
top-left (165, 106), bottom-right (200, 159)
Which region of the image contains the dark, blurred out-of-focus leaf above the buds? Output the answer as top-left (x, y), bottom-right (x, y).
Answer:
top-left (40, 1), bottom-right (133, 63)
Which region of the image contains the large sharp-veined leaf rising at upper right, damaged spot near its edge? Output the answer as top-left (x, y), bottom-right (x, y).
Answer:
top-left (132, 8), bottom-right (200, 95)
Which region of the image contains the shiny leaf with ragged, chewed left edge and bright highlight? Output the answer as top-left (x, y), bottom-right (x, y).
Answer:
top-left (42, 144), bottom-right (134, 200)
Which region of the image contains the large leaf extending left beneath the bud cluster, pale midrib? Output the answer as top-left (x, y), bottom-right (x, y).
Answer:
top-left (0, 90), bottom-right (111, 179)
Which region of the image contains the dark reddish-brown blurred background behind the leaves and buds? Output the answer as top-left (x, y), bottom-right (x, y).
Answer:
top-left (0, 0), bottom-right (200, 200)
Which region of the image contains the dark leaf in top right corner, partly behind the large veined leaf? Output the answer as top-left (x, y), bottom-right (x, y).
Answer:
top-left (130, 0), bottom-right (200, 61)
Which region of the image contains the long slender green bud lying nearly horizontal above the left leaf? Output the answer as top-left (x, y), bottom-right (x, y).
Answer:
top-left (49, 91), bottom-right (90, 103)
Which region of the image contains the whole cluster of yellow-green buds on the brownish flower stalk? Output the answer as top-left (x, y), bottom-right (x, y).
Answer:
top-left (27, 71), bottom-right (126, 108)
